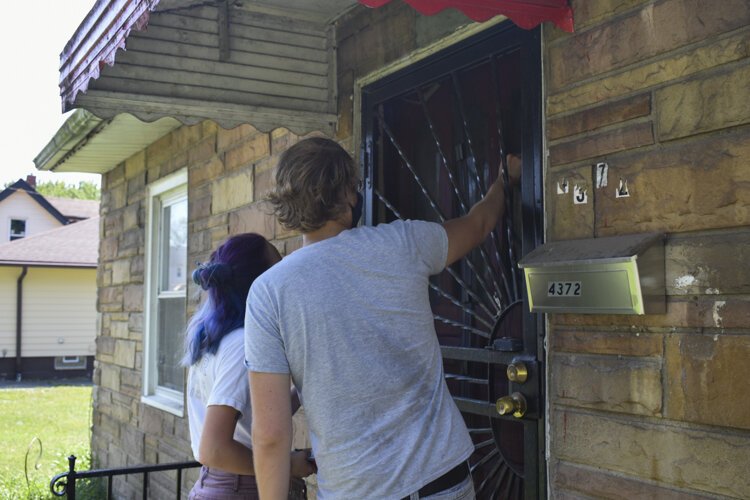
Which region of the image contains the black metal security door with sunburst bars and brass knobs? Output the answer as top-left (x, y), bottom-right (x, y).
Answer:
top-left (362, 23), bottom-right (545, 499)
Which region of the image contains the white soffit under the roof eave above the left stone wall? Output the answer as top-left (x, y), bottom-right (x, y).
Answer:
top-left (34, 109), bottom-right (181, 174)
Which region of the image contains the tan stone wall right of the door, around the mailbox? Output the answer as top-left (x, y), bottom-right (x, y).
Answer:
top-left (544, 0), bottom-right (750, 498)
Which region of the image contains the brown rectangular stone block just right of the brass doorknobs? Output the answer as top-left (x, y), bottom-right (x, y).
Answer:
top-left (549, 354), bottom-right (662, 416)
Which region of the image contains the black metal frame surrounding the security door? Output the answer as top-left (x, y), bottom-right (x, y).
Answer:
top-left (355, 21), bottom-right (548, 498)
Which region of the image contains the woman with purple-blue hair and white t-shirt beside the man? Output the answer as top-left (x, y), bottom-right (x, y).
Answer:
top-left (185, 233), bottom-right (315, 500)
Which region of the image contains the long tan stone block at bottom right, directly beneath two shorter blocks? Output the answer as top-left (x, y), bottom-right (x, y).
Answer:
top-left (551, 410), bottom-right (750, 498)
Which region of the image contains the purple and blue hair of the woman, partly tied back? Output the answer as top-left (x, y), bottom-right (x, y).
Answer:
top-left (184, 233), bottom-right (274, 365)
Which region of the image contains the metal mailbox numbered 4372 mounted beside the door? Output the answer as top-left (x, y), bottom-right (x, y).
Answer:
top-left (518, 233), bottom-right (666, 314)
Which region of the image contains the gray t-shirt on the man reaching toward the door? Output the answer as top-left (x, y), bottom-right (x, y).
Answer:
top-left (245, 221), bottom-right (473, 500)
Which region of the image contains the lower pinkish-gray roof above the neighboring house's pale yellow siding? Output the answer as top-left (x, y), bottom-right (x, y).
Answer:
top-left (0, 217), bottom-right (99, 267)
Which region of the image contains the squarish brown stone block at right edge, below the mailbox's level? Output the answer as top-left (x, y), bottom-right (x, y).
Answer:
top-left (666, 334), bottom-right (750, 429)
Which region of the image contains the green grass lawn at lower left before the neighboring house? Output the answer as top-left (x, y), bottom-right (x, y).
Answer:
top-left (0, 384), bottom-right (91, 500)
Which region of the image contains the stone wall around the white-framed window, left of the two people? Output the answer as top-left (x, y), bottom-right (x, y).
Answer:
top-left (92, 122), bottom-right (301, 498)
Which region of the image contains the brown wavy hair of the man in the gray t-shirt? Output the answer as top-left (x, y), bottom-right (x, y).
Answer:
top-left (268, 137), bottom-right (359, 233)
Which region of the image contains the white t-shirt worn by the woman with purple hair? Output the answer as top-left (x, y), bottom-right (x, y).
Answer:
top-left (187, 328), bottom-right (252, 460)
